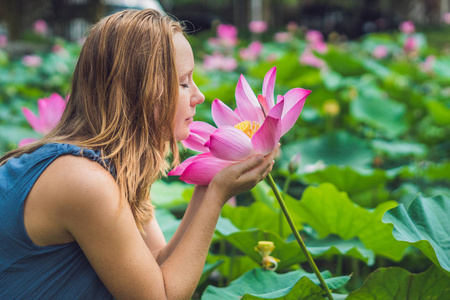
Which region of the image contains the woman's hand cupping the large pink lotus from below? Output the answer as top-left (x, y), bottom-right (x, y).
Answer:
top-left (210, 144), bottom-right (280, 205)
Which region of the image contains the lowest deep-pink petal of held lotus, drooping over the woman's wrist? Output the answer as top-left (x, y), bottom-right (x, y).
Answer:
top-left (180, 153), bottom-right (234, 185)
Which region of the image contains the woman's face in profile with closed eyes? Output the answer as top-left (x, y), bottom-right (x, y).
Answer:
top-left (173, 33), bottom-right (205, 141)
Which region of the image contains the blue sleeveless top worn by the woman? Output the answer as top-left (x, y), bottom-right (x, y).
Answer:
top-left (0, 144), bottom-right (113, 299)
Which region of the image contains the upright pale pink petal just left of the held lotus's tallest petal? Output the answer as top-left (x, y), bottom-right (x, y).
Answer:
top-left (236, 75), bottom-right (264, 124)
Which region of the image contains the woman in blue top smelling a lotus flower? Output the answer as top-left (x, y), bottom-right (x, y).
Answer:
top-left (0, 10), bottom-right (276, 299)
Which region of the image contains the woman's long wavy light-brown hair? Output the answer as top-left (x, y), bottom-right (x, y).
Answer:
top-left (0, 9), bottom-right (183, 232)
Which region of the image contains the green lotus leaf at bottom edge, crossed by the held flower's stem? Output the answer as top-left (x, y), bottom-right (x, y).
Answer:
top-left (201, 268), bottom-right (350, 300)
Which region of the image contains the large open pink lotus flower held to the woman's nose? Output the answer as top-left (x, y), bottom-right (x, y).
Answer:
top-left (169, 67), bottom-right (311, 185)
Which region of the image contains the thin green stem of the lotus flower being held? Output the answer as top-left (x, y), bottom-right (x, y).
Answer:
top-left (266, 174), bottom-right (333, 300)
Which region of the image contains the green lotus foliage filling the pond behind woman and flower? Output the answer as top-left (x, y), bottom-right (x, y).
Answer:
top-left (0, 19), bottom-right (450, 299)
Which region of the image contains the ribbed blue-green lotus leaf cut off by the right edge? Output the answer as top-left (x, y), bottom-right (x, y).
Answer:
top-left (383, 195), bottom-right (450, 272)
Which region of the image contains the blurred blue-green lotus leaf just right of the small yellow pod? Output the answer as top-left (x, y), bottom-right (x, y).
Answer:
top-left (350, 97), bottom-right (408, 137)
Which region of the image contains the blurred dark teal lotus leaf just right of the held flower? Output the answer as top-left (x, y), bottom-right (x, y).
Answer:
top-left (281, 131), bottom-right (374, 173)
